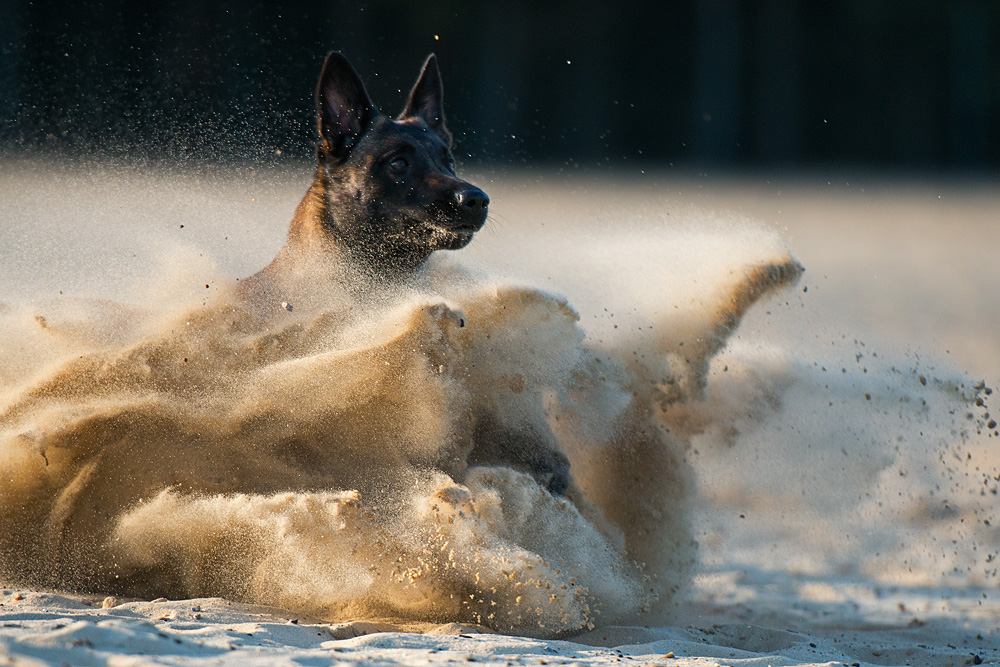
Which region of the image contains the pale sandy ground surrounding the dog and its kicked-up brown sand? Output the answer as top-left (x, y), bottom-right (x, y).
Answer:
top-left (0, 165), bottom-right (1000, 666)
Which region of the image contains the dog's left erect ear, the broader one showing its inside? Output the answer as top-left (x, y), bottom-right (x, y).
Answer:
top-left (316, 51), bottom-right (378, 159)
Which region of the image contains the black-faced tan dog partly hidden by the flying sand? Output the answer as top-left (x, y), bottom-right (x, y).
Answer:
top-left (240, 52), bottom-right (570, 494)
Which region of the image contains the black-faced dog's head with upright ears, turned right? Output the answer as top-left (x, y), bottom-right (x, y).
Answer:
top-left (316, 53), bottom-right (489, 268)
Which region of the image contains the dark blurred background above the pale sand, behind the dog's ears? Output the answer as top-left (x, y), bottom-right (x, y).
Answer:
top-left (0, 0), bottom-right (1000, 172)
